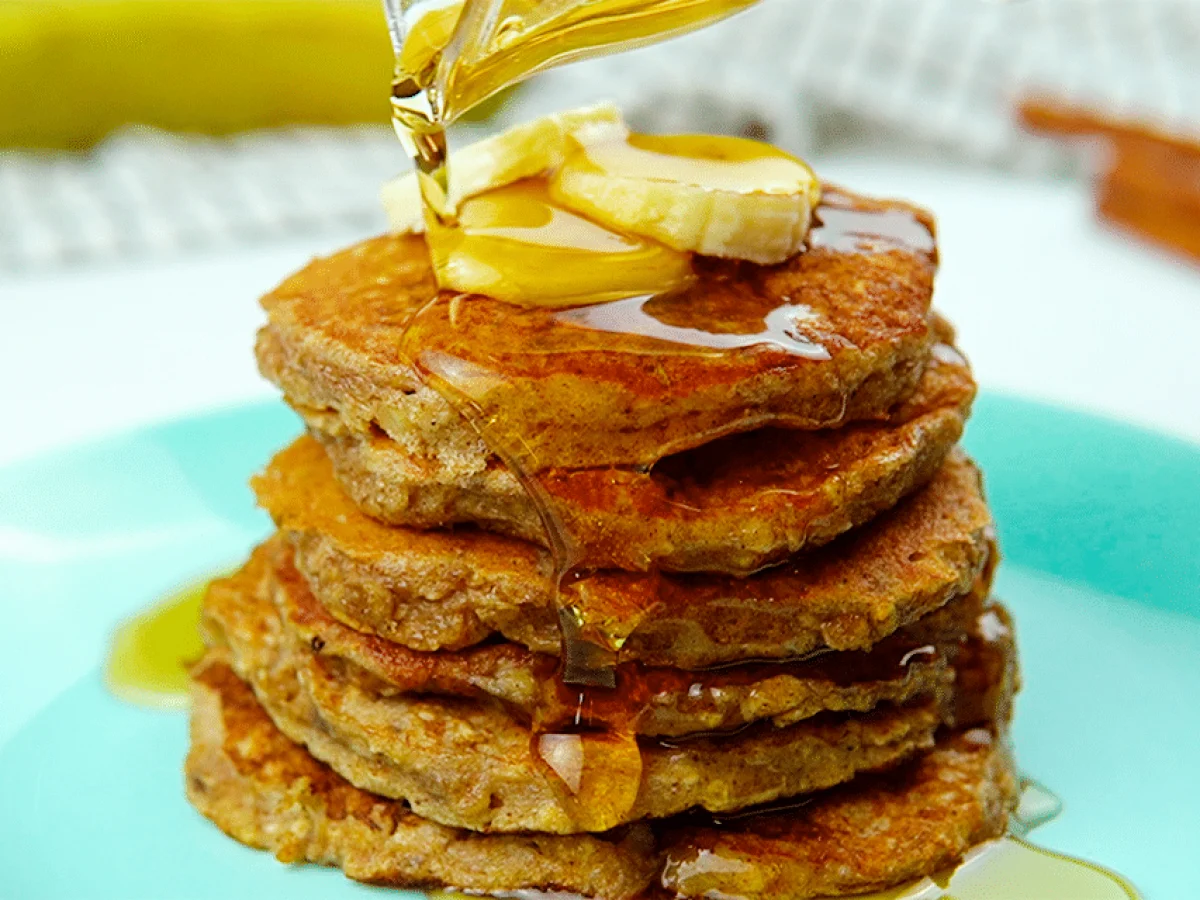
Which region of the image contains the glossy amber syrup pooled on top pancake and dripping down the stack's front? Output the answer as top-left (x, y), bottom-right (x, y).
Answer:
top-left (401, 183), bottom-right (950, 840)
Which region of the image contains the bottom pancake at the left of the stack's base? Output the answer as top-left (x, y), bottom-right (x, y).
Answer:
top-left (186, 652), bottom-right (658, 900)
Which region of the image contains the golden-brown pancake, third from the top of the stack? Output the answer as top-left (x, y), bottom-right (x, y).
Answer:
top-left (260, 438), bottom-right (991, 668)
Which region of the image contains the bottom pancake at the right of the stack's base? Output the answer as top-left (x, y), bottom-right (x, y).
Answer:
top-left (660, 728), bottom-right (1018, 900)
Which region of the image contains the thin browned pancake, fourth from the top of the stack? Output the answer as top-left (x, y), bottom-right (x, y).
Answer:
top-left (253, 540), bottom-right (989, 737)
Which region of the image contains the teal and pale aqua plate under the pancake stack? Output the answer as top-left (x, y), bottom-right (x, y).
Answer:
top-left (0, 396), bottom-right (1200, 900)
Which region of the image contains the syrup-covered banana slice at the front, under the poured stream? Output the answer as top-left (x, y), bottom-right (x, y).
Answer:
top-left (428, 179), bottom-right (695, 307)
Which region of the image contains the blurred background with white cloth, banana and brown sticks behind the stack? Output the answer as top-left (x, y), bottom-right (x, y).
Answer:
top-left (0, 0), bottom-right (1200, 461)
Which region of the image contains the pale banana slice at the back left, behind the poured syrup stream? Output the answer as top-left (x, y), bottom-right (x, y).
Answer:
top-left (383, 103), bottom-right (629, 234)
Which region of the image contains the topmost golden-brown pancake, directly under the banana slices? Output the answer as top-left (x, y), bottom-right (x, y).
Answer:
top-left (257, 188), bottom-right (936, 479)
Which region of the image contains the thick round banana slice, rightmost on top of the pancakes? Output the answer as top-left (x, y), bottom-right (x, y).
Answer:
top-left (551, 134), bottom-right (821, 264)
